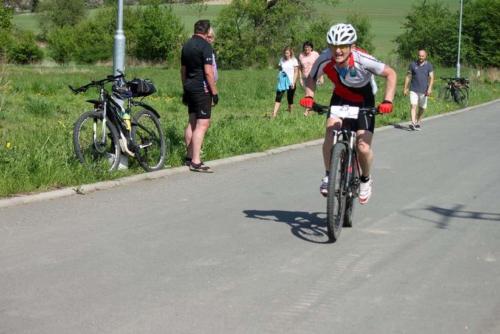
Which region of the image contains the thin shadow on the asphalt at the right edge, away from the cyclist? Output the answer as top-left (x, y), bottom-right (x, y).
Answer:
top-left (404, 204), bottom-right (500, 229)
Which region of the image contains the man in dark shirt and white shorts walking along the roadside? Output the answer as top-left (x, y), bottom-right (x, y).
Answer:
top-left (403, 50), bottom-right (434, 131)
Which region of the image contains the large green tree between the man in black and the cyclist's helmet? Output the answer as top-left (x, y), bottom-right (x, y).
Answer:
top-left (215, 0), bottom-right (338, 68)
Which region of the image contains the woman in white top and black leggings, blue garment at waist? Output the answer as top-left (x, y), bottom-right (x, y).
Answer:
top-left (273, 46), bottom-right (299, 117)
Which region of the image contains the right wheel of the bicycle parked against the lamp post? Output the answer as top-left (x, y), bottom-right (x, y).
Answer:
top-left (131, 109), bottom-right (167, 172)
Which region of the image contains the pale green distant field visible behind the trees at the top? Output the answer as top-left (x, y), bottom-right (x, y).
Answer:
top-left (14, 0), bottom-right (459, 56)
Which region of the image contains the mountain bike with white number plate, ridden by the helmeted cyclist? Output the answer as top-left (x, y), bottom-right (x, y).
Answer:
top-left (304, 103), bottom-right (379, 242)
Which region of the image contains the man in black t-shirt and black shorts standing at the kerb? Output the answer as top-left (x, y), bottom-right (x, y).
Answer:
top-left (181, 20), bottom-right (219, 173)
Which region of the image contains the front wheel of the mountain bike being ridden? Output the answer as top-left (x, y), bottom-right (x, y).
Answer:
top-left (326, 143), bottom-right (348, 242)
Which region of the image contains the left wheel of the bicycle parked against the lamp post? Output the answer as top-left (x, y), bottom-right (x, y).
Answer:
top-left (73, 111), bottom-right (120, 171)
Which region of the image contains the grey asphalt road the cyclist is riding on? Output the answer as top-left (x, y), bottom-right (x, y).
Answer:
top-left (0, 102), bottom-right (500, 334)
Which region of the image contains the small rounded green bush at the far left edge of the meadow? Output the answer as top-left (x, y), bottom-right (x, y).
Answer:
top-left (7, 31), bottom-right (43, 64)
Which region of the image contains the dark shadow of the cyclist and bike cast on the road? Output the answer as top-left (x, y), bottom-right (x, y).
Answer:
top-left (243, 210), bottom-right (330, 244)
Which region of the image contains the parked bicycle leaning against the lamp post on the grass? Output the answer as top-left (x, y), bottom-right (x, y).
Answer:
top-left (69, 73), bottom-right (166, 171)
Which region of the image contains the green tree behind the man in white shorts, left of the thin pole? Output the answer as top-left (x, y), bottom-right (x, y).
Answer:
top-left (395, 0), bottom-right (458, 66)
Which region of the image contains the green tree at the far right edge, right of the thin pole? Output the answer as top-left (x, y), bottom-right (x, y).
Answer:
top-left (462, 0), bottom-right (500, 67)
